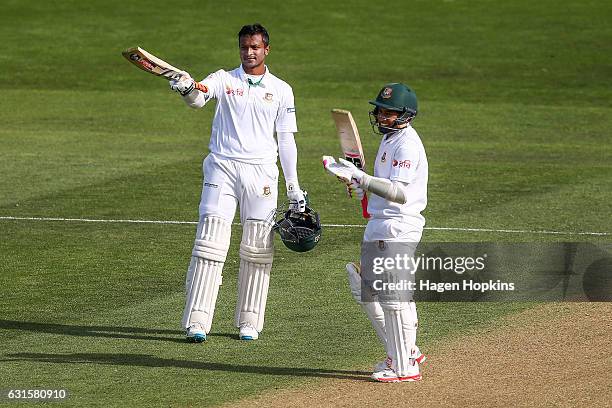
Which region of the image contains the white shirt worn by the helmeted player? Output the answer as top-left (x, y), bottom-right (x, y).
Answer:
top-left (364, 126), bottom-right (429, 241)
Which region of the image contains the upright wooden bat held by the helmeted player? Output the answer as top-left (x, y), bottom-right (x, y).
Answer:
top-left (332, 109), bottom-right (370, 218)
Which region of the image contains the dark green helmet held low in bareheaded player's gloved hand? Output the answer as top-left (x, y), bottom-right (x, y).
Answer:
top-left (274, 205), bottom-right (321, 252)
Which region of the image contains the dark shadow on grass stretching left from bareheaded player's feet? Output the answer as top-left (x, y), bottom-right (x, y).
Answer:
top-left (0, 320), bottom-right (185, 343)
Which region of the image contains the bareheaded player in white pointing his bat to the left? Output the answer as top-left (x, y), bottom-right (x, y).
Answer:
top-left (170, 24), bottom-right (306, 343)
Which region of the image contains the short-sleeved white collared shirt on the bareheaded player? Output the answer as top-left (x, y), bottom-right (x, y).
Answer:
top-left (200, 65), bottom-right (297, 164)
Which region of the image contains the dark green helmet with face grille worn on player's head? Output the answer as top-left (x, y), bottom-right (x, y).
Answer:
top-left (370, 82), bottom-right (418, 131)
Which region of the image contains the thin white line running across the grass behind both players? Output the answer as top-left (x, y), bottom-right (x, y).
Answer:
top-left (0, 216), bottom-right (612, 236)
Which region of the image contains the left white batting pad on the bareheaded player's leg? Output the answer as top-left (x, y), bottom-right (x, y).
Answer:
top-left (182, 216), bottom-right (231, 333)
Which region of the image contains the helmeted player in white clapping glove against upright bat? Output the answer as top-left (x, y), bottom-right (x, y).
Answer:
top-left (323, 83), bottom-right (428, 382)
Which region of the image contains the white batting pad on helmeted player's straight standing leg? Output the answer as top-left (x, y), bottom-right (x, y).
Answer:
top-left (382, 302), bottom-right (417, 377)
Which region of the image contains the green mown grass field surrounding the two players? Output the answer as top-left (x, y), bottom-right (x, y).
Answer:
top-left (0, 0), bottom-right (612, 406)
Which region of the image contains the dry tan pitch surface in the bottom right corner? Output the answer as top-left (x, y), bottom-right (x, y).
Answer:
top-left (230, 303), bottom-right (612, 407)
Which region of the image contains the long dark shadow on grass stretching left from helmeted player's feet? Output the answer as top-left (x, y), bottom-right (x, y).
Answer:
top-left (0, 353), bottom-right (369, 381)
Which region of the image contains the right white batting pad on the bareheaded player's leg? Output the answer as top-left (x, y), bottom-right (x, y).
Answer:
top-left (235, 220), bottom-right (274, 332)
